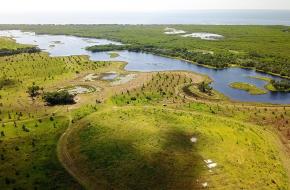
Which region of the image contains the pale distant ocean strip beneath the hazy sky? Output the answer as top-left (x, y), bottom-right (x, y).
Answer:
top-left (0, 10), bottom-right (290, 26)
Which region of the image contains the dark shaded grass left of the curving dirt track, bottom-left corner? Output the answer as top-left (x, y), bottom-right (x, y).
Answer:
top-left (0, 117), bottom-right (80, 189)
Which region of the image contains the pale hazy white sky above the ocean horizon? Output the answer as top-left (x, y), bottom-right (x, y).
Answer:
top-left (0, 0), bottom-right (290, 14)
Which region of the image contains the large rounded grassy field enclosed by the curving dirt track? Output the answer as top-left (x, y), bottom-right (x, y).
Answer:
top-left (69, 107), bottom-right (288, 189)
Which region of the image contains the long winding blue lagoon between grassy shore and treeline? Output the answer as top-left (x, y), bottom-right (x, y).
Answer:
top-left (0, 30), bottom-right (290, 104)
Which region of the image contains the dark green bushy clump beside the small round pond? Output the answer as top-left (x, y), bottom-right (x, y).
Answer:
top-left (43, 90), bottom-right (75, 105)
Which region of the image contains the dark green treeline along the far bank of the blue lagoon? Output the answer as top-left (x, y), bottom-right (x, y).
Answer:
top-left (87, 44), bottom-right (290, 77)
